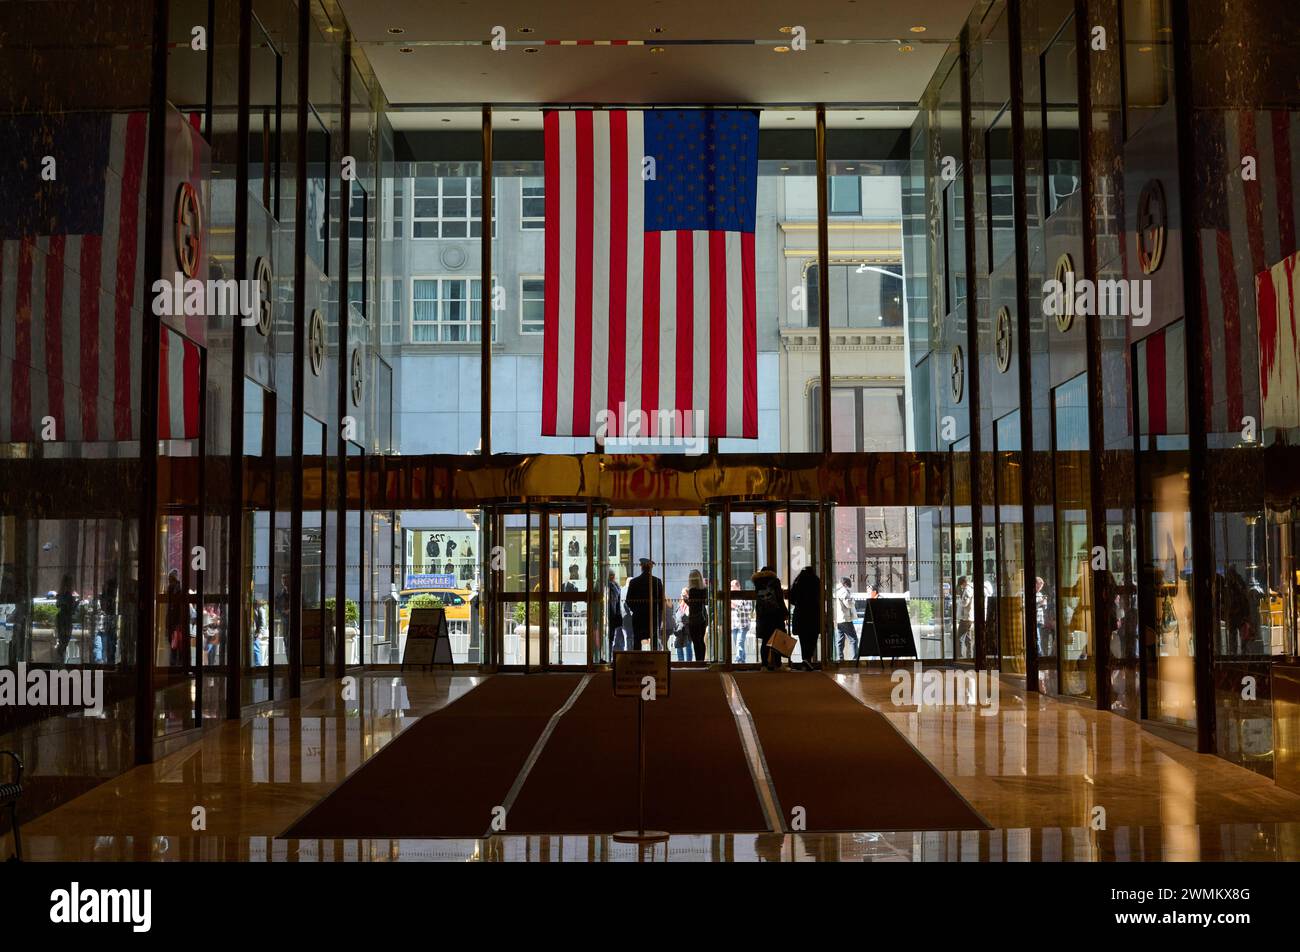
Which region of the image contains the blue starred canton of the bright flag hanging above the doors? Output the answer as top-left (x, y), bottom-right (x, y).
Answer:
top-left (645, 109), bottom-right (758, 231)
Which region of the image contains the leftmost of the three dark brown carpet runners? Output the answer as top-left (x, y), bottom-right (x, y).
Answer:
top-left (282, 675), bottom-right (580, 839)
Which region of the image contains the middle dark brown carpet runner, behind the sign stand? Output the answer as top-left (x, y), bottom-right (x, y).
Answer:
top-left (508, 670), bottom-right (767, 834)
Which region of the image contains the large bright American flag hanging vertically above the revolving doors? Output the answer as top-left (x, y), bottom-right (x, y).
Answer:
top-left (542, 109), bottom-right (758, 438)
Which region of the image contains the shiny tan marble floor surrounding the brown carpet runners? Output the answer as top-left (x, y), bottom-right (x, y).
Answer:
top-left (5, 671), bottom-right (1300, 862)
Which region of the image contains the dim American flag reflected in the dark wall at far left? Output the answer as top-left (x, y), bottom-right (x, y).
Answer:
top-left (0, 112), bottom-right (147, 442)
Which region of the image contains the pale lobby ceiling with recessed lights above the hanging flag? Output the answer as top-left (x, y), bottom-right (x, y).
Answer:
top-left (339, 0), bottom-right (974, 116)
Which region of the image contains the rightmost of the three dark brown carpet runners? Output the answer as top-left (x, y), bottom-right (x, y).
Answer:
top-left (736, 672), bottom-right (991, 832)
